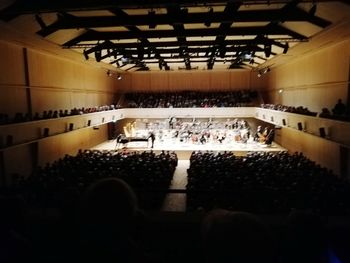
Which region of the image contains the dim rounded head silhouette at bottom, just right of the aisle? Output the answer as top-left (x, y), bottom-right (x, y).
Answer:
top-left (202, 209), bottom-right (275, 263)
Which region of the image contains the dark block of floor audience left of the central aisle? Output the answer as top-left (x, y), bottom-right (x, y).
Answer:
top-left (12, 150), bottom-right (177, 209)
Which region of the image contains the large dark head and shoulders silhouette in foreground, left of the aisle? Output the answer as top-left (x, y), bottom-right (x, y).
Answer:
top-left (79, 178), bottom-right (145, 262)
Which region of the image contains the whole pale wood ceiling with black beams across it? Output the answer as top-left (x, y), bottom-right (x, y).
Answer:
top-left (0, 0), bottom-right (350, 72)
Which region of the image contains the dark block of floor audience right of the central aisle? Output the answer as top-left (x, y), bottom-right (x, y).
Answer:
top-left (187, 152), bottom-right (350, 214)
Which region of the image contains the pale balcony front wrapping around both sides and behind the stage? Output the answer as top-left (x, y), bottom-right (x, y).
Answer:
top-left (0, 107), bottom-right (350, 149)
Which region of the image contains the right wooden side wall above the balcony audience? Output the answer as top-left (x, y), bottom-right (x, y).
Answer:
top-left (264, 40), bottom-right (350, 112)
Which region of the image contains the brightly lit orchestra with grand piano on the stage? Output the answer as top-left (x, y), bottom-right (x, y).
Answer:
top-left (116, 117), bottom-right (275, 151)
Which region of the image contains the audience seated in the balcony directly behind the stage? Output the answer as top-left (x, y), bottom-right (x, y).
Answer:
top-left (125, 90), bottom-right (257, 108)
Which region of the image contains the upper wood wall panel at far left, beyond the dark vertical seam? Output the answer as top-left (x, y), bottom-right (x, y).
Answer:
top-left (0, 41), bottom-right (25, 85)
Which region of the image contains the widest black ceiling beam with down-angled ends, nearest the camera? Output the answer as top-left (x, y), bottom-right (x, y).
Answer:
top-left (37, 8), bottom-right (330, 37)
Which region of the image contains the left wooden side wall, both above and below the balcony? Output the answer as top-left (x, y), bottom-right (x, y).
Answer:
top-left (0, 40), bottom-right (117, 184)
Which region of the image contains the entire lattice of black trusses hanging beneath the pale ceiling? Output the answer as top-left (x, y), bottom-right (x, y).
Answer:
top-left (0, 0), bottom-right (331, 70)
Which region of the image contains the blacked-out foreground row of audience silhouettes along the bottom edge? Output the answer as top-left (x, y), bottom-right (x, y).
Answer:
top-left (0, 177), bottom-right (340, 263)
